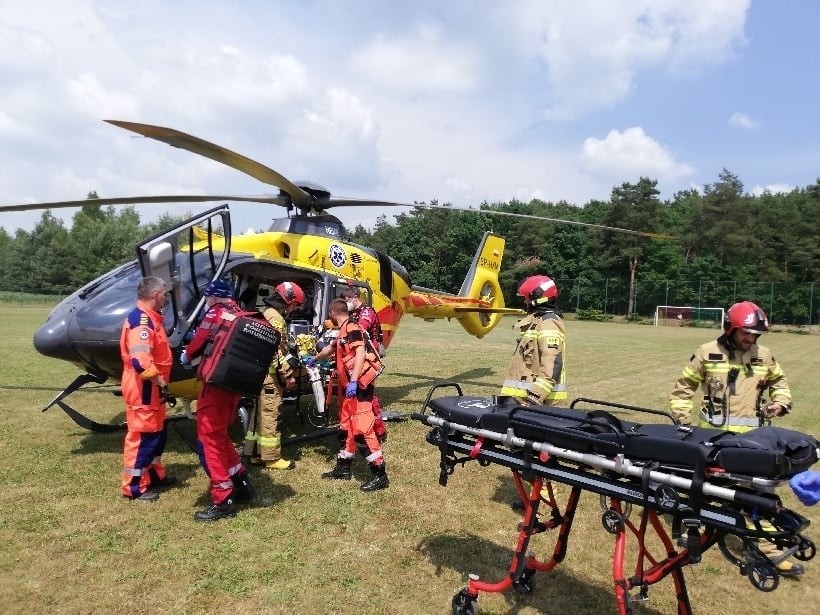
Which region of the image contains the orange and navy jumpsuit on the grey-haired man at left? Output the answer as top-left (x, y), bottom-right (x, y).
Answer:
top-left (120, 301), bottom-right (173, 498)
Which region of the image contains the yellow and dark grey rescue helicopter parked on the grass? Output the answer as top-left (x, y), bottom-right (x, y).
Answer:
top-left (0, 120), bottom-right (518, 431)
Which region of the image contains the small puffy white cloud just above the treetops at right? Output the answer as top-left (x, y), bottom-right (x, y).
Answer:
top-left (581, 127), bottom-right (695, 181)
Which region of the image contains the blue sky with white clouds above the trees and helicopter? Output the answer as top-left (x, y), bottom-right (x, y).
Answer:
top-left (0, 0), bottom-right (820, 232)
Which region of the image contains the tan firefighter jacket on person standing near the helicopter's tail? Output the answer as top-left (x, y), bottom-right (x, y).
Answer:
top-left (501, 310), bottom-right (567, 406)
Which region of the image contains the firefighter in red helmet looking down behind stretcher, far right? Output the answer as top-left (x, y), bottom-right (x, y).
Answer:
top-left (669, 301), bottom-right (803, 577)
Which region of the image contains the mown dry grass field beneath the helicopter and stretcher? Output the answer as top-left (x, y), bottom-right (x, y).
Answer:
top-left (0, 303), bottom-right (820, 615)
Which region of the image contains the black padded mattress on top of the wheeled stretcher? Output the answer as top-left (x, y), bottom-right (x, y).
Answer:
top-left (428, 395), bottom-right (819, 479)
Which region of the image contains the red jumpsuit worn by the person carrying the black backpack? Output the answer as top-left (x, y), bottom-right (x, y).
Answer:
top-left (185, 300), bottom-right (245, 504)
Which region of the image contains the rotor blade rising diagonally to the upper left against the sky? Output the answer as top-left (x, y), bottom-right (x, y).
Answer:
top-left (105, 120), bottom-right (313, 210)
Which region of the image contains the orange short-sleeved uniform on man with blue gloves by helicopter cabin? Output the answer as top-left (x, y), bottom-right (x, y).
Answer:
top-left (336, 320), bottom-right (384, 468)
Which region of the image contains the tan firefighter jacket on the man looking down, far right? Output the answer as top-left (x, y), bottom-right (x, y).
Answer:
top-left (669, 336), bottom-right (792, 431)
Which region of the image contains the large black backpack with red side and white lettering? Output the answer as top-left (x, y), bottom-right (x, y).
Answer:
top-left (197, 312), bottom-right (281, 397)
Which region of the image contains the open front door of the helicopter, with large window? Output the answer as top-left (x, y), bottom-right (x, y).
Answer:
top-left (137, 205), bottom-right (231, 347)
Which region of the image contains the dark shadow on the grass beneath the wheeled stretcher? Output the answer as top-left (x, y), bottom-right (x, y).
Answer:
top-left (416, 533), bottom-right (671, 615)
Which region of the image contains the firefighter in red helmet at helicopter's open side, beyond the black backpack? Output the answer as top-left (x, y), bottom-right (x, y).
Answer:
top-left (244, 282), bottom-right (305, 470)
